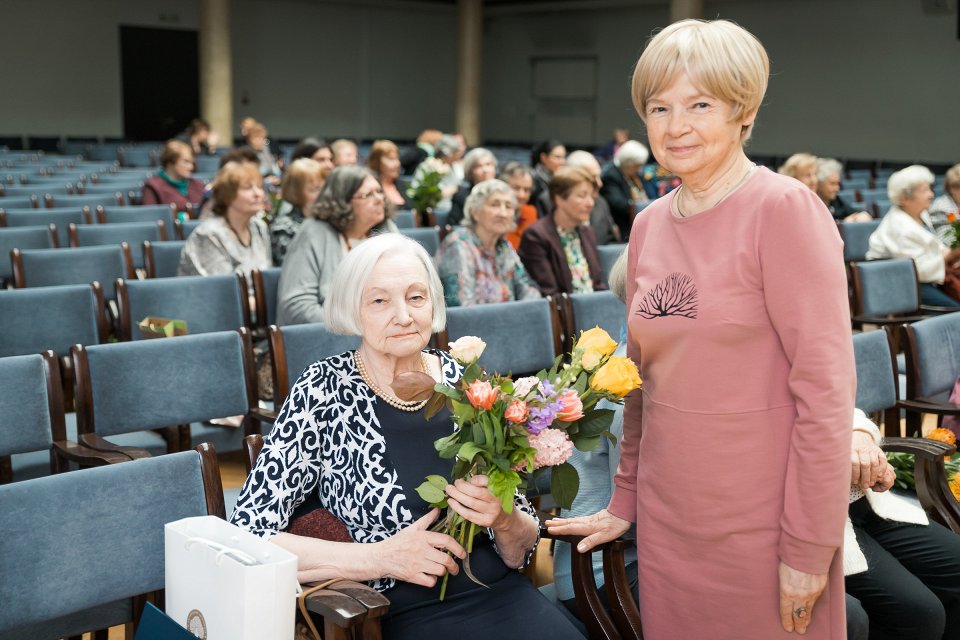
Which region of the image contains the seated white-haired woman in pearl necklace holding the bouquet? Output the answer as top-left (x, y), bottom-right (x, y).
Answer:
top-left (231, 234), bottom-right (581, 640)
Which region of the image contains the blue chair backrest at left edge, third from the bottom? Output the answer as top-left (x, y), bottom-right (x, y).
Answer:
top-left (0, 282), bottom-right (108, 357)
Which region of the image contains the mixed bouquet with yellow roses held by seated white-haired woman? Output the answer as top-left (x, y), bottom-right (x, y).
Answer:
top-left (394, 328), bottom-right (641, 600)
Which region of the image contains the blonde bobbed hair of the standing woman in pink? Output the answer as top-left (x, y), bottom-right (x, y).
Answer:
top-left (632, 20), bottom-right (770, 142)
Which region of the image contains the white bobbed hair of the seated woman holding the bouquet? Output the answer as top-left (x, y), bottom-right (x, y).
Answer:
top-left (323, 232), bottom-right (447, 336)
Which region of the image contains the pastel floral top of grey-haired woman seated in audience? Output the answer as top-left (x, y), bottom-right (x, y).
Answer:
top-left (437, 227), bottom-right (544, 307)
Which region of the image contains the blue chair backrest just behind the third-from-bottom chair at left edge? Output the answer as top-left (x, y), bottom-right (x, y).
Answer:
top-left (11, 244), bottom-right (135, 295)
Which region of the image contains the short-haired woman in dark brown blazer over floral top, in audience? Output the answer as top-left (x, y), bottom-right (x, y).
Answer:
top-left (517, 167), bottom-right (607, 295)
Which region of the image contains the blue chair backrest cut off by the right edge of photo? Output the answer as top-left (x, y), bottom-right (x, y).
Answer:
top-left (902, 313), bottom-right (960, 402)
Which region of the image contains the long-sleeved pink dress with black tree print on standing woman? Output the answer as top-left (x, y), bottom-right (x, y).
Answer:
top-left (610, 167), bottom-right (856, 640)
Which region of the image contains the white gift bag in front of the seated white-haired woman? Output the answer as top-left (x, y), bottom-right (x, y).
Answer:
top-left (164, 516), bottom-right (300, 640)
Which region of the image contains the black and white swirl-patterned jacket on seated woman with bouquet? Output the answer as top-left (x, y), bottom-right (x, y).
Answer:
top-left (230, 351), bottom-right (539, 591)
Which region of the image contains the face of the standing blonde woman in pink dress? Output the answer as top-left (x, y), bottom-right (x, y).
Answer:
top-left (645, 74), bottom-right (753, 184)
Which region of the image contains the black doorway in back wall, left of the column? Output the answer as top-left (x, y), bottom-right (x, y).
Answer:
top-left (120, 26), bottom-right (200, 141)
